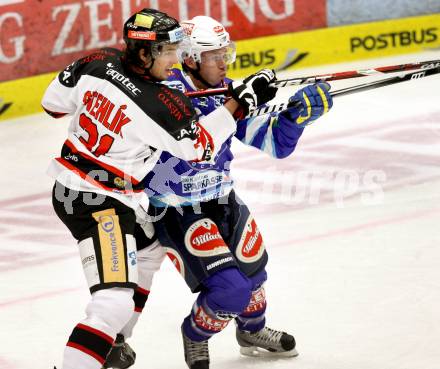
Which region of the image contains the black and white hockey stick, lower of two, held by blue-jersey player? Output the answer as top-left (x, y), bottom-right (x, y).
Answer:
top-left (247, 61), bottom-right (440, 118)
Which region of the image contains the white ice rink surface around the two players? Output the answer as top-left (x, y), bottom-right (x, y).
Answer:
top-left (0, 52), bottom-right (440, 369)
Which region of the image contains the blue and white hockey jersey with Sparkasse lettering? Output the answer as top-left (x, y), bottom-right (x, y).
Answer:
top-left (144, 69), bottom-right (303, 207)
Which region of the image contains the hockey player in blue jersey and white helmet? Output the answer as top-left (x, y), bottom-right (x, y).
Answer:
top-left (141, 16), bottom-right (332, 369)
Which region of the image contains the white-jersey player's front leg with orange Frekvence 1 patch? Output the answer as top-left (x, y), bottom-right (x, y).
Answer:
top-left (52, 183), bottom-right (137, 369)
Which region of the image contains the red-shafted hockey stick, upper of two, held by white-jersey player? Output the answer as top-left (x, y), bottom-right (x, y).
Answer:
top-left (185, 60), bottom-right (440, 97)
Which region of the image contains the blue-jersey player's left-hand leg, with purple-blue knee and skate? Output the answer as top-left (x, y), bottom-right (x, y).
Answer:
top-left (152, 207), bottom-right (251, 369)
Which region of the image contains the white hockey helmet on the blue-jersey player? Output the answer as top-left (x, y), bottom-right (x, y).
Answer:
top-left (178, 15), bottom-right (236, 64)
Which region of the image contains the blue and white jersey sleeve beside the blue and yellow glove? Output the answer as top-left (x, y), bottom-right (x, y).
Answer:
top-left (235, 113), bottom-right (304, 159)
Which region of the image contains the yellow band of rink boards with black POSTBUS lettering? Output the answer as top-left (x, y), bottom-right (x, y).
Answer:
top-left (0, 13), bottom-right (440, 121)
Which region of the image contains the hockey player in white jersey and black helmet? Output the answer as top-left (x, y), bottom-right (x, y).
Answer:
top-left (42, 9), bottom-right (278, 369)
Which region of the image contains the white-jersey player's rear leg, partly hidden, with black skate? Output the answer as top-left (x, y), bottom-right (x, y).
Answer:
top-left (104, 223), bottom-right (165, 369)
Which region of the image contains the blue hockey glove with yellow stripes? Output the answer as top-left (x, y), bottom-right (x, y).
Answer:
top-left (281, 82), bottom-right (333, 127)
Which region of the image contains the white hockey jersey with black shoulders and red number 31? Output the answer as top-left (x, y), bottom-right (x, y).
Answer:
top-left (42, 48), bottom-right (236, 208)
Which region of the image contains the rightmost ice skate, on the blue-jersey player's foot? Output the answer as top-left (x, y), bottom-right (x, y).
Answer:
top-left (236, 327), bottom-right (298, 357)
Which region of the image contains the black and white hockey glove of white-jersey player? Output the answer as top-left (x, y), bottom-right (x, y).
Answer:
top-left (228, 69), bottom-right (278, 114)
